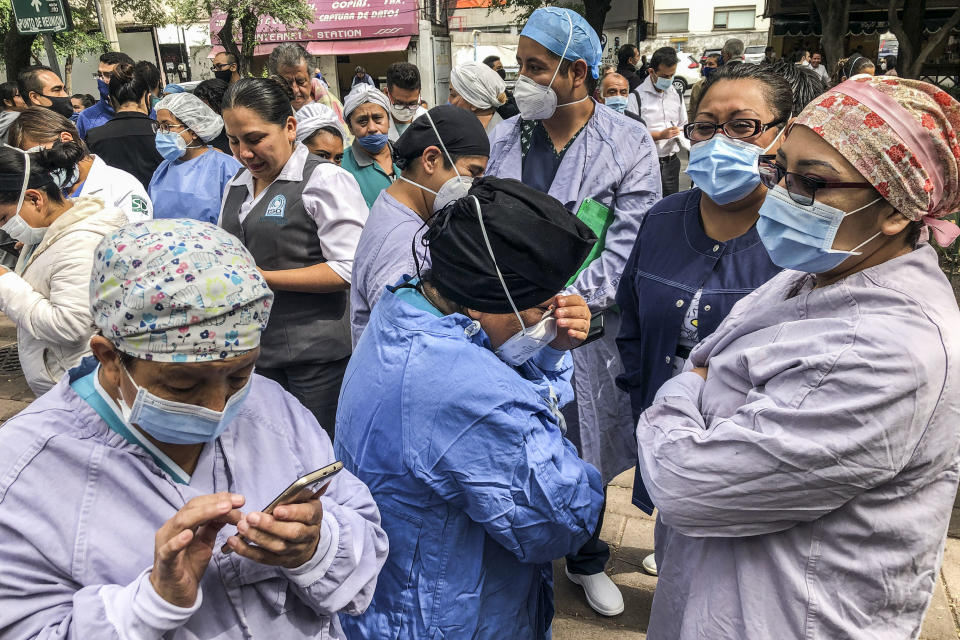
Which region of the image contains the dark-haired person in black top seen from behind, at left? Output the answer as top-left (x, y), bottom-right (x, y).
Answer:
top-left (86, 63), bottom-right (163, 188)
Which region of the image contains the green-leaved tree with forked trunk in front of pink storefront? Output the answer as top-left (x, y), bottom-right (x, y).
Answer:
top-left (171, 0), bottom-right (314, 76)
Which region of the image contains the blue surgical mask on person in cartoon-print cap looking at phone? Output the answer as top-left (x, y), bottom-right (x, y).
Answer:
top-left (117, 367), bottom-right (253, 444)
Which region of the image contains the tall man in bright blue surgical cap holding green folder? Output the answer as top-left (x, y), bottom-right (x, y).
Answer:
top-left (487, 7), bottom-right (660, 615)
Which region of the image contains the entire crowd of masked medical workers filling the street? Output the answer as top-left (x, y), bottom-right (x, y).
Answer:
top-left (0, 7), bottom-right (960, 640)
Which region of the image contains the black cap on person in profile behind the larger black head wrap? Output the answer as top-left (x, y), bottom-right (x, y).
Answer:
top-left (394, 104), bottom-right (490, 158)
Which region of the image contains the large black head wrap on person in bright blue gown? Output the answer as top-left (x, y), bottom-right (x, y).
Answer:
top-left (423, 177), bottom-right (597, 313)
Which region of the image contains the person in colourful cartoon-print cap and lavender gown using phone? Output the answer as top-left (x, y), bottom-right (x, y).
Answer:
top-left (0, 220), bottom-right (387, 639)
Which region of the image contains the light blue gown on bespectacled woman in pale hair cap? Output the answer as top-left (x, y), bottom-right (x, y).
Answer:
top-left (147, 148), bottom-right (241, 224)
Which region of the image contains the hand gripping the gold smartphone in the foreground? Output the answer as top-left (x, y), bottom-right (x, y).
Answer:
top-left (227, 487), bottom-right (326, 569)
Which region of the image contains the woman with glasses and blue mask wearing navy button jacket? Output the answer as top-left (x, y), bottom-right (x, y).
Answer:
top-left (617, 64), bottom-right (793, 575)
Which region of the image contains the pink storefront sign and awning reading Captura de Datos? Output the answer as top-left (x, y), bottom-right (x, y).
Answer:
top-left (210, 0), bottom-right (418, 52)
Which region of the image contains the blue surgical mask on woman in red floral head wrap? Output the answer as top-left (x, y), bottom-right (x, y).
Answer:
top-left (757, 185), bottom-right (882, 273)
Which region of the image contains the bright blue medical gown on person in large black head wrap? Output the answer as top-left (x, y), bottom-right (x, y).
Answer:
top-left (335, 290), bottom-right (603, 640)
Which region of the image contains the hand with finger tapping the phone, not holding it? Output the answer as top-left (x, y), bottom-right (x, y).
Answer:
top-left (150, 492), bottom-right (244, 607)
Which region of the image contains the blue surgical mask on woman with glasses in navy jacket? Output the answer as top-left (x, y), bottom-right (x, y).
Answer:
top-left (686, 127), bottom-right (786, 204)
